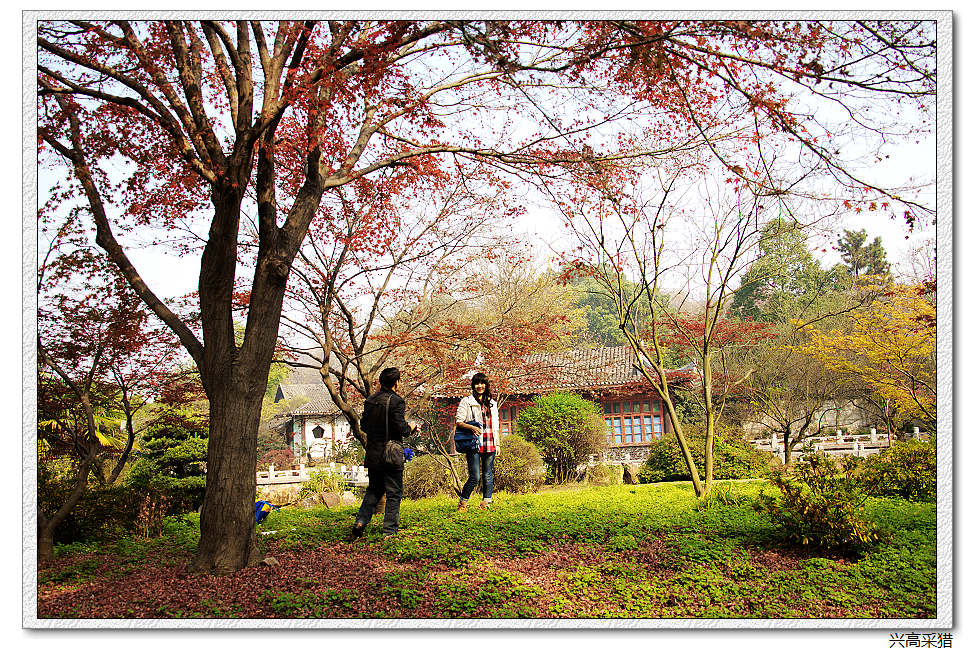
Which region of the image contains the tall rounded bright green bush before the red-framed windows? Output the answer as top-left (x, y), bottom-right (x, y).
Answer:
top-left (518, 392), bottom-right (606, 483)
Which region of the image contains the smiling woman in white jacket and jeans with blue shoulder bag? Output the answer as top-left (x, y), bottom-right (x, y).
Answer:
top-left (457, 372), bottom-right (501, 512)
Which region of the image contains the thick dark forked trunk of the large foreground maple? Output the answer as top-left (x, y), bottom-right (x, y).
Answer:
top-left (190, 185), bottom-right (288, 575)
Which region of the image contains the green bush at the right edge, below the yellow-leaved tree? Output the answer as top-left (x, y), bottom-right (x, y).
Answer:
top-left (856, 440), bottom-right (938, 502)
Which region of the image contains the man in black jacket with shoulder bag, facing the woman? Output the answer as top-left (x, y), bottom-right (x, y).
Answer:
top-left (352, 367), bottom-right (414, 539)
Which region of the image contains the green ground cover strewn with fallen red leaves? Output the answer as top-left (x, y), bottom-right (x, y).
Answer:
top-left (37, 480), bottom-right (936, 619)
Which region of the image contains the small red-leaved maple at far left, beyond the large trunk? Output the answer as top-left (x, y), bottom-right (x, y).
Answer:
top-left (37, 235), bottom-right (176, 561)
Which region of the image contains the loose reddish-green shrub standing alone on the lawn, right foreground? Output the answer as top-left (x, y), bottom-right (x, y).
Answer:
top-left (756, 455), bottom-right (880, 552)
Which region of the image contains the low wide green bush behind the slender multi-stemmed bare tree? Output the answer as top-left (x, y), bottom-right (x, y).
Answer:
top-left (639, 424), bottom-right (774, 483)
